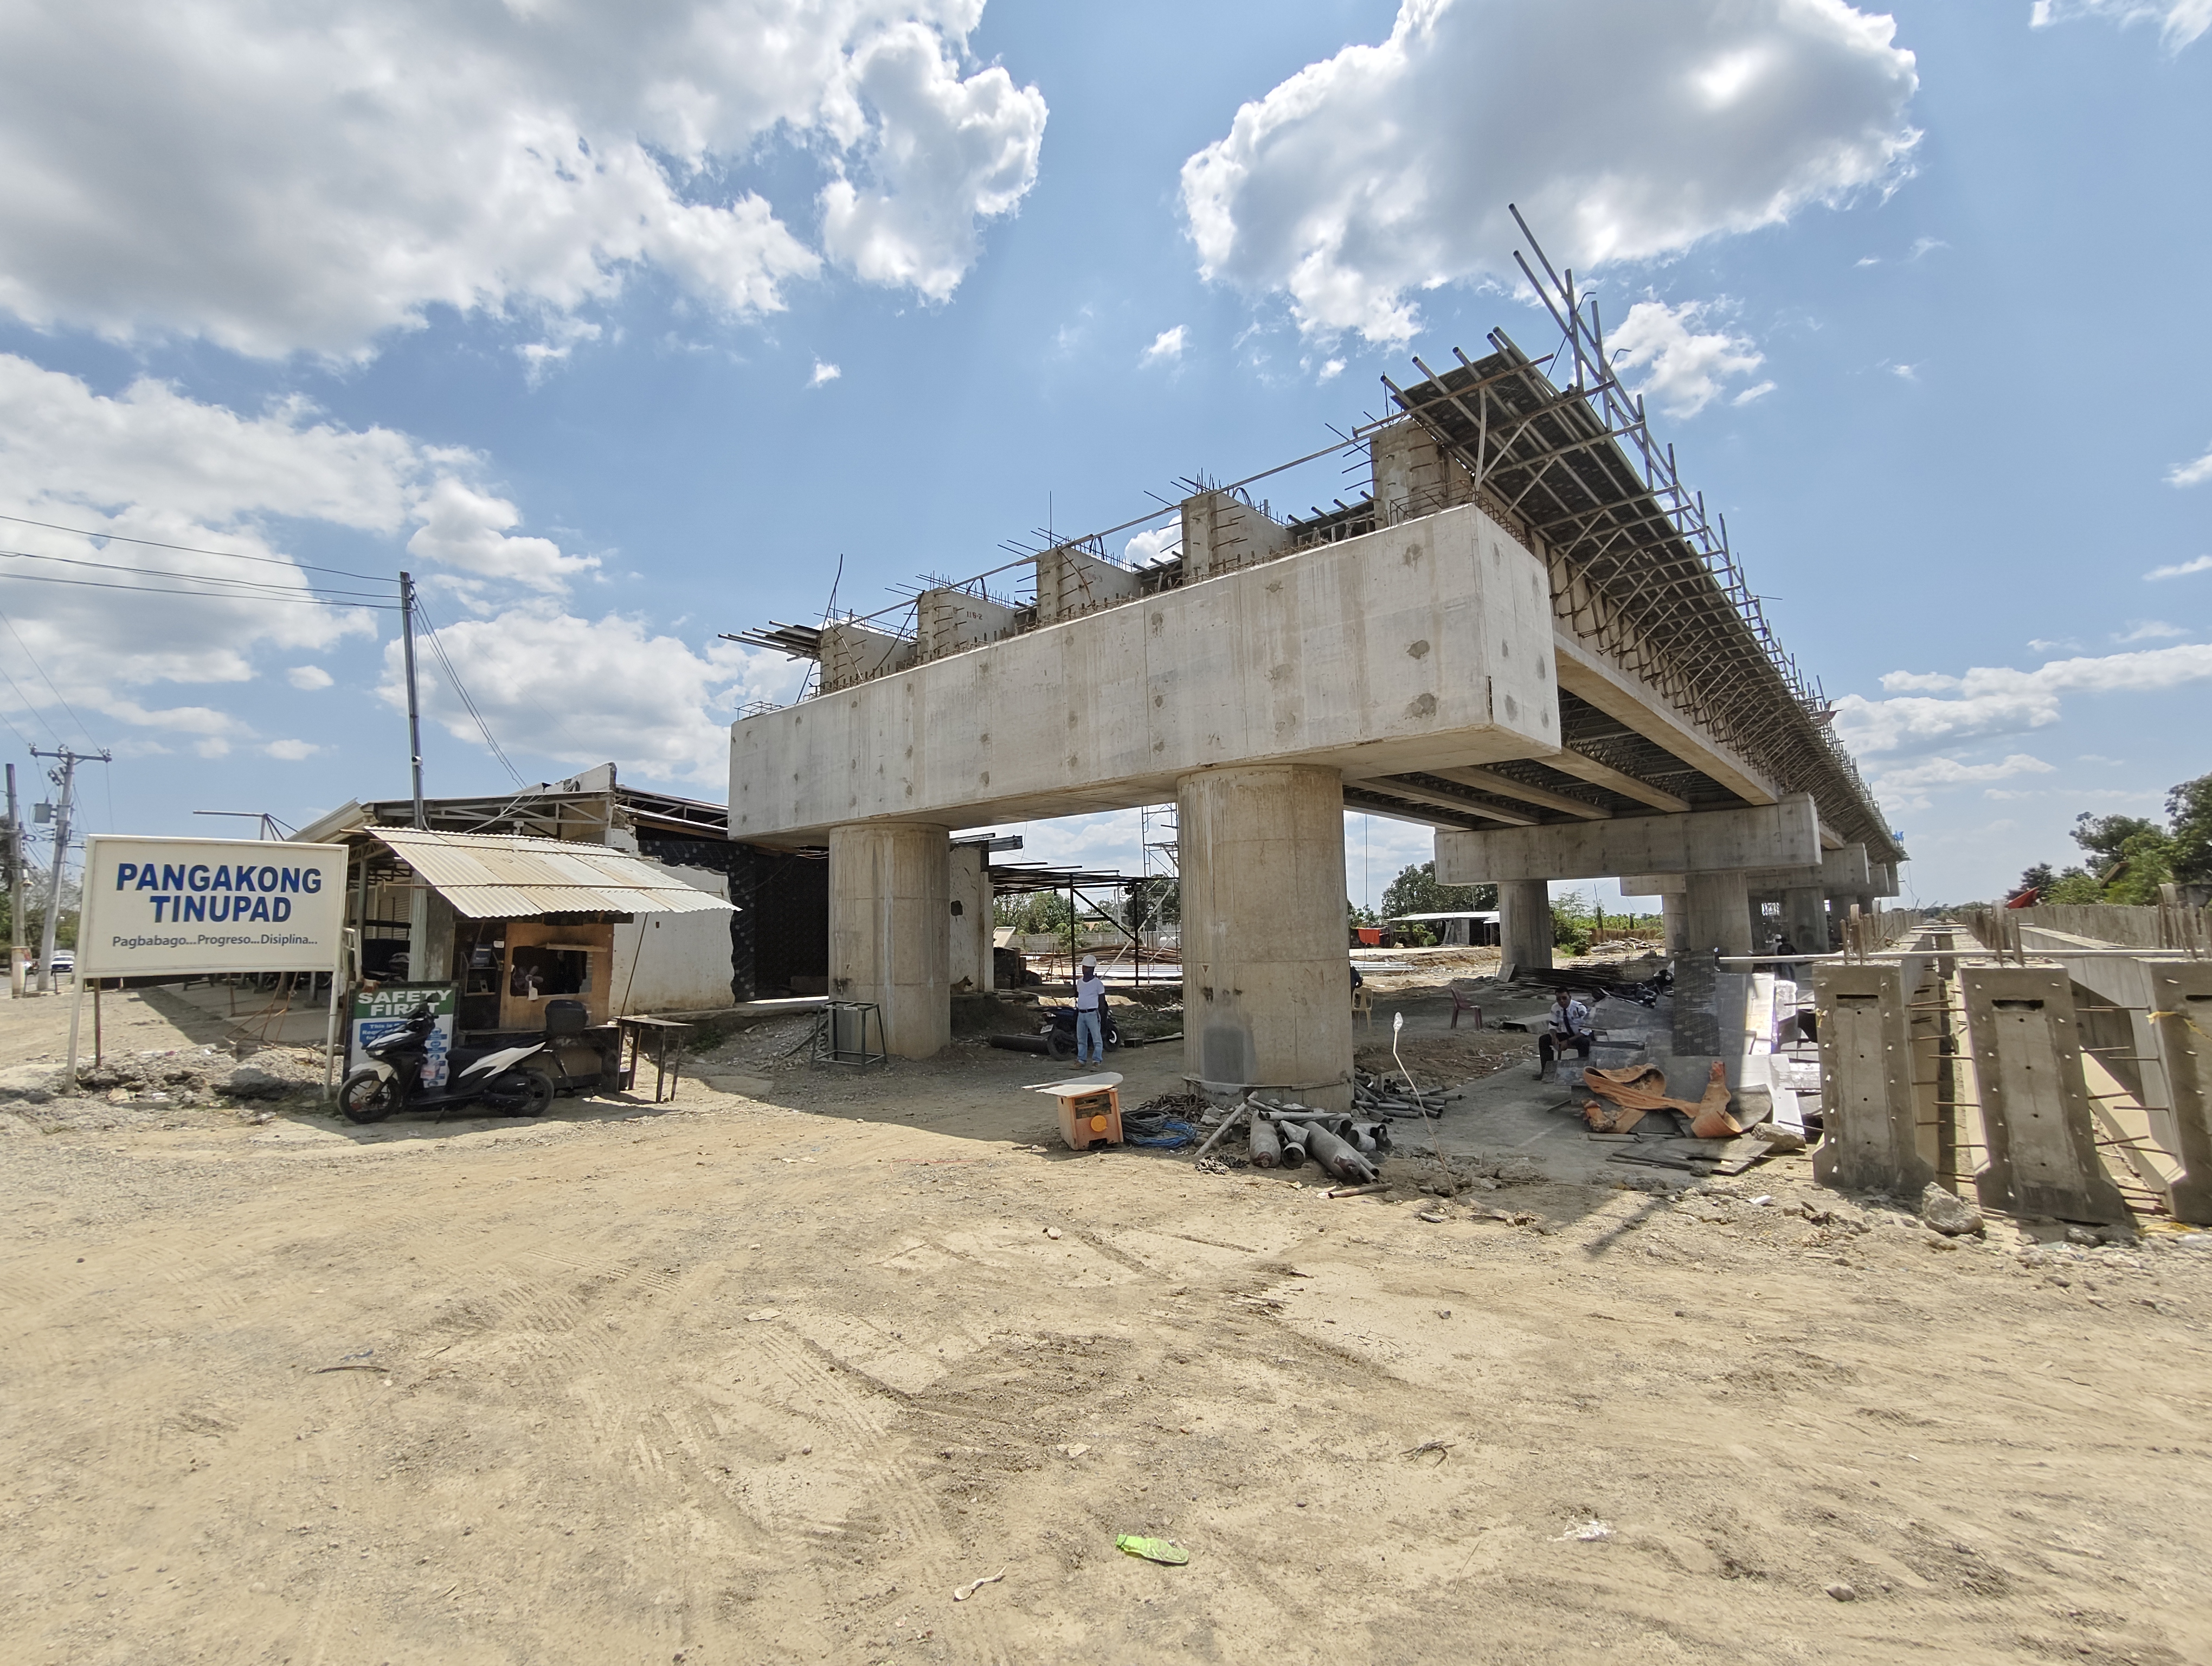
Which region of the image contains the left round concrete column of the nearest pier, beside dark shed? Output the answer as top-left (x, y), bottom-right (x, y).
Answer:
top-left (829, 821), bottom-right (953, 1058)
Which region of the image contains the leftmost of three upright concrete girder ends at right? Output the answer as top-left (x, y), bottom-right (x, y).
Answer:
top-left (1812, 960), bottom-right (1935, 1197)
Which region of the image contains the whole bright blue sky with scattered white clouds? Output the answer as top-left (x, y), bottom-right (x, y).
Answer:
top-left (0, 0), bottom-right (2212, 900)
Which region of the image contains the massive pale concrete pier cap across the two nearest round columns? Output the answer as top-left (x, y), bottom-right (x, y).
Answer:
top-left (730, 504), bottom-right (1559, 845)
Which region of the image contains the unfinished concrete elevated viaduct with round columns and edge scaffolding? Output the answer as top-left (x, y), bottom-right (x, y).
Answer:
top-left (730, 221), bottom-right (1905, 1108)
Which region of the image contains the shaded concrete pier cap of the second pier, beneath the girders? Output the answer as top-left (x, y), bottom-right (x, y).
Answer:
top-left (1436, 792), bottom-right (1821, 885)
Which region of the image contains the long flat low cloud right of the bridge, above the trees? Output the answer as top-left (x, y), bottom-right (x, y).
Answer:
top-left (1836, 644), bottom-right (2212, 752)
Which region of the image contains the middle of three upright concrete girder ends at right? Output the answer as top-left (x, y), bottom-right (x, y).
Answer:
top-left (1960, 967), bottom-right (2128, 1221)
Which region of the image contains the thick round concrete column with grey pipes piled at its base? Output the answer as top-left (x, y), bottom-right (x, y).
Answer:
top-left (1177, 766), bottom-right (1352, 1111)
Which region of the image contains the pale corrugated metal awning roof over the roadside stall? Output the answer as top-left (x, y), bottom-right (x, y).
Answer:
top-left (365, 828), bottom-right (737, 920)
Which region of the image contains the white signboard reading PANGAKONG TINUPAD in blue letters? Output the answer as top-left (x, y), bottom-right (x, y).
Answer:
top-left (78, 834), bottom-right (345, 978)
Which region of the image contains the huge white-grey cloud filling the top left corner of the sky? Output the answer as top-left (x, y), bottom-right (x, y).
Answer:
top-left (0, 0), bottom-right (1046, 358)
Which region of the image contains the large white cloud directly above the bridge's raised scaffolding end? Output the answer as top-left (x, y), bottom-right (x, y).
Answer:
top-left (1184, 0), bottom-right (1918, 343)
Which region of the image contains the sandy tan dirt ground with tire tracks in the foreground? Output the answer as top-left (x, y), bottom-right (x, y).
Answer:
top-left (0, 982), bottom-right (2212, 1666)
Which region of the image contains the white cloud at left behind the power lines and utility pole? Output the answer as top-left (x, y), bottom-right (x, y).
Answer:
top-left (0, 354), bottom-right (590, 752)
